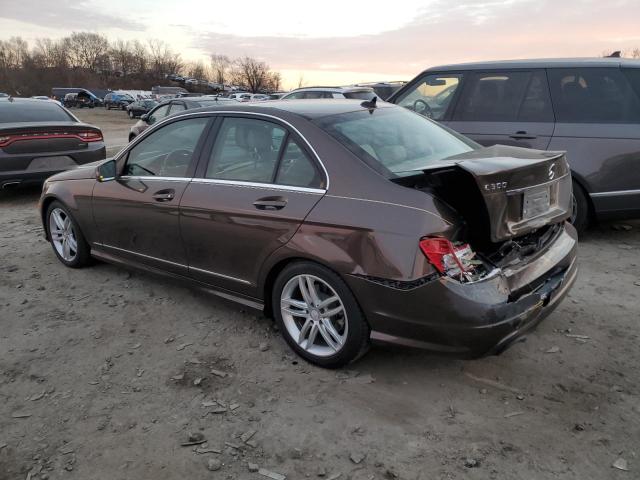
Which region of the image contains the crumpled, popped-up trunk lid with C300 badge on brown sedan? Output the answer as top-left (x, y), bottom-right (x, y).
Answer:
top-left (424, 145), bottom-right (572, 243)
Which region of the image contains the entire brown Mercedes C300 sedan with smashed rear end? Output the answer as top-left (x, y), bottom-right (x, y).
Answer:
top-left (40, 100), bottom-right (577, 367)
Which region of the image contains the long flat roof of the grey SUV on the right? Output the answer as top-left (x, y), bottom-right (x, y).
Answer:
top-left (425, 57), bottom-right (640, 72)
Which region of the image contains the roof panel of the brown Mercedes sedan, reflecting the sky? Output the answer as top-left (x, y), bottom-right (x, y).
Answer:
top-left (180, 99), bottom-right (401, 120)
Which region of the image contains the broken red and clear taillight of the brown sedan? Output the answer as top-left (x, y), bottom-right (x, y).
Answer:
top-left (420, 237), bottom-right (478, 277)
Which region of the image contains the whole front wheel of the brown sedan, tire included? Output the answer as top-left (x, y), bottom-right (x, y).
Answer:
top-left (45, 200), bottom-right (91, 268)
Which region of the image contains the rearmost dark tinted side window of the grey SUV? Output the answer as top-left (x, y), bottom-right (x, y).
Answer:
top-left (548, 68), bottom-right (640, 123)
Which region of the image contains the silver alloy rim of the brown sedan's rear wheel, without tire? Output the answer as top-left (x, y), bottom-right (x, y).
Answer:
top-left (280, 275), bottom-right (349, 357)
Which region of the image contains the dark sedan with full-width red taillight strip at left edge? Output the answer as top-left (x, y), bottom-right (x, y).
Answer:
top-left (0, 98), bottom-right (105, 188)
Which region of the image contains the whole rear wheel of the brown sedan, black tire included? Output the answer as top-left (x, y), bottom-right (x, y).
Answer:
top-left (272, 262), bottom-right (370, 368)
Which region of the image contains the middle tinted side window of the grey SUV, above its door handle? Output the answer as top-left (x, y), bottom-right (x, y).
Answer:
top-left (454, 70), bottom-right (553, 122)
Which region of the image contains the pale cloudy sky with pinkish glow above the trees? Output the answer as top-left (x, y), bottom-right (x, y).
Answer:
top-left (0, 0), bottom-right (640, 87)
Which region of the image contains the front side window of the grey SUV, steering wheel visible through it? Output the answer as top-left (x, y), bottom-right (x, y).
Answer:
top-left (395, 74), bottom-right (462, 120)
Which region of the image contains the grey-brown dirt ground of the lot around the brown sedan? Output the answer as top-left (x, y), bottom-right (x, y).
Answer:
top-left (0, 107), bottom-right (640, 480)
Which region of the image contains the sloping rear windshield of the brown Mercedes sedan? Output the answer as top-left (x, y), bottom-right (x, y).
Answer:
top-left (314, 107), bottom-right (478, 175)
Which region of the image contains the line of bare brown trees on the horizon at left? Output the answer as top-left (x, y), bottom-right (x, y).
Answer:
top-left (0, 32), bottom-right (281, 96)
